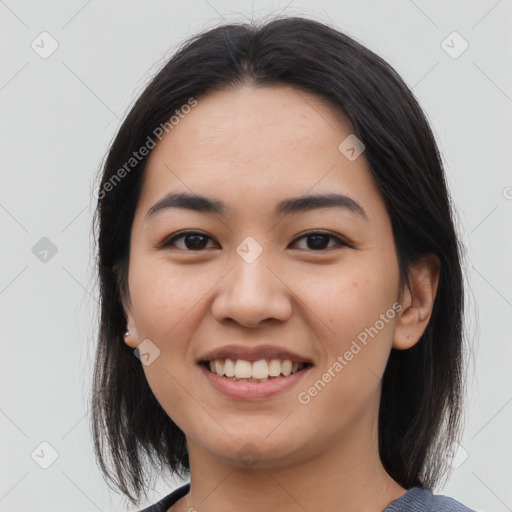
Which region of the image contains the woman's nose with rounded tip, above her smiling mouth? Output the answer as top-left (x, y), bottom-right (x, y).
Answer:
top-left (212, 253), bottom-right (292, 327)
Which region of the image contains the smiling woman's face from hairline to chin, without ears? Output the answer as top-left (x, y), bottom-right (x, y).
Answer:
top-left (126, 86), bottom-right (412, 467)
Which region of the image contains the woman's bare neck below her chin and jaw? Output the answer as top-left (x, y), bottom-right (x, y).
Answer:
top-left (176, 412), bottom-right (405, 512)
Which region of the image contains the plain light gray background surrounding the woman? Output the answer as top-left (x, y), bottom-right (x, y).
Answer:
top-left (0, 0), bottom-right (512, 512)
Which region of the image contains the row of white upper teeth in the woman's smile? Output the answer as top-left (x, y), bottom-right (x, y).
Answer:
top-left (209, 358), bottom-right (305, 382)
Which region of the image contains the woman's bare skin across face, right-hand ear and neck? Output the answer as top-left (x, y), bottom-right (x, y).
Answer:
top-left (121, 86), bottom-right (439, 512)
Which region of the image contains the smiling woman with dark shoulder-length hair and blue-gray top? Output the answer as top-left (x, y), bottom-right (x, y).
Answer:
top-left (93, 18), bottom-right (476, 512)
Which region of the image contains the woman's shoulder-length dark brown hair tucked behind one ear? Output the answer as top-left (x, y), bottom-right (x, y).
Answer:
top-left (92, 17), bottom-right (464, 503)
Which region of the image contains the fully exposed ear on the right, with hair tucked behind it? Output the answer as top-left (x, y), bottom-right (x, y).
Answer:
top-left (392, 254), bottom-right (441, 350)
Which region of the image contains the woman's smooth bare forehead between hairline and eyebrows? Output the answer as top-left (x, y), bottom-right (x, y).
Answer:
top-left (135, 86), bottom-right (379, 223)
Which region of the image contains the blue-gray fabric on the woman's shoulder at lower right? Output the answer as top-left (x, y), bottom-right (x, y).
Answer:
top-left (383, 487), bottom-right (475, 512)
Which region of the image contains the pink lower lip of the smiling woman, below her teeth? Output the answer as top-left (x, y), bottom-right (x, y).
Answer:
top-left (200, 365), bottom-right (310, 400)
